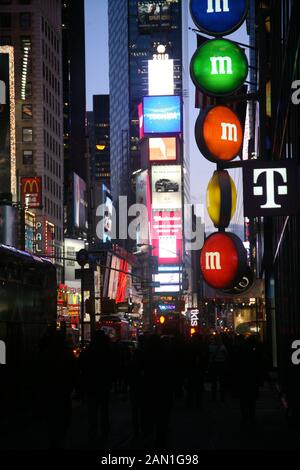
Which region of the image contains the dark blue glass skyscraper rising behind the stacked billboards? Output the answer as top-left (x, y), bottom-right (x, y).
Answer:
top-left (108, 0), bottom-right (188, 205)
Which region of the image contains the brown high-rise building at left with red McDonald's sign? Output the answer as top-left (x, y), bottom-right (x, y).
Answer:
top-left (0, 0), bottom-right (63, 278)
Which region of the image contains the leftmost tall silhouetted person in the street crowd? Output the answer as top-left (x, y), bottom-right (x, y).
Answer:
top-left (36, 327), bottom-right (76, 450)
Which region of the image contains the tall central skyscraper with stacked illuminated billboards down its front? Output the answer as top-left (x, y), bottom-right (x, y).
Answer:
top-left (108, 0), bottom-right (189, 323)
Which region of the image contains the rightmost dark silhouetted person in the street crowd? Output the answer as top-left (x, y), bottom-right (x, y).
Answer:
top-left (235, 336), bottom-right (264, 424)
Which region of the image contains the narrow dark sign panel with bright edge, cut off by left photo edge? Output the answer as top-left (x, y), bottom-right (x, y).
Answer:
top-left (0, 53), bottom-right (11, 193)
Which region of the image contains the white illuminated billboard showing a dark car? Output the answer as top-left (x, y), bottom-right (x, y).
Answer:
top-left (152, 165), bottom-right (182, 210)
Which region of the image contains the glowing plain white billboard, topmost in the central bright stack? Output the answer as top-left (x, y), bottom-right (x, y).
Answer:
top-left (148, 59), bottom-right (174, 96)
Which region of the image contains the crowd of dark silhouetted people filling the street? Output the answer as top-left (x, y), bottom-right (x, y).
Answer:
top-left (36, 324), bottom-right (267, 448)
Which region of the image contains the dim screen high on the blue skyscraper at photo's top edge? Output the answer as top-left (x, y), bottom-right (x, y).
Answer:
top-left (138, 0), bottom-right (172, 34)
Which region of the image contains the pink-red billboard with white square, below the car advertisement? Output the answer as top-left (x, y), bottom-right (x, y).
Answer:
top-left (152, 210), bottom-right (182, 264)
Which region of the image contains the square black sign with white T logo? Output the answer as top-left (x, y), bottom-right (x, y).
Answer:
top-left (243, 160), bottom-right (299, 217)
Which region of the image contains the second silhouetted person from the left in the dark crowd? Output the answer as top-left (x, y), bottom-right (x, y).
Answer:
top-left (81, 331), bottom-right (115, 441)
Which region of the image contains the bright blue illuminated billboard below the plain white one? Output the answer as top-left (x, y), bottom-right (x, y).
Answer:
top-left (143, 96), bottom-right (182, 137)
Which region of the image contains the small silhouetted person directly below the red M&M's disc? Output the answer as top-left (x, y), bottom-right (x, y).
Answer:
top-left (208, 335), bottom-right (228, 401)
